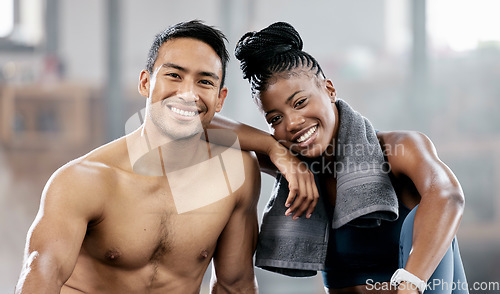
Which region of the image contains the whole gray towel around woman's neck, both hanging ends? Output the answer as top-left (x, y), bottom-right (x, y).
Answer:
top-left (255, 100), bottom-right (398, 277)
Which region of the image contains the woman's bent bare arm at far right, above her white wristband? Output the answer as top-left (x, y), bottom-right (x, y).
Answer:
top-left (382, 132), bottom-right (464, 293)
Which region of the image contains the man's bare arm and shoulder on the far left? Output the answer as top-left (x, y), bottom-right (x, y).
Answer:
top-left (15, 163), bottom-right (103, 293)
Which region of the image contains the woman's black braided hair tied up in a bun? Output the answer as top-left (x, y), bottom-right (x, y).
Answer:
top-left (235, 22), bottom-right (324, 97)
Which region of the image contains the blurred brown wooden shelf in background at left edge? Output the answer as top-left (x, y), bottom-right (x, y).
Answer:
top-left (0, 84), bottom-right (91, 149)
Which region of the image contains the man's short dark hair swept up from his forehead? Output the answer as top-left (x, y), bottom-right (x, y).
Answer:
top-left (146, 20), bottom-right (229, 87)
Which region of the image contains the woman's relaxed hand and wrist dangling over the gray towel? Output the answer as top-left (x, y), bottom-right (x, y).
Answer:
top-left (268, 142), bottom-right (319, 220)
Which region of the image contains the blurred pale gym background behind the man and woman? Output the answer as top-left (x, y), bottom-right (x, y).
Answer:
top-left (0, 0), bottom-right (500, 294)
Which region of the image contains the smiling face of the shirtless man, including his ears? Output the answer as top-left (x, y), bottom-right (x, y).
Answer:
top-left (139, 38), bottom-right (227, 139)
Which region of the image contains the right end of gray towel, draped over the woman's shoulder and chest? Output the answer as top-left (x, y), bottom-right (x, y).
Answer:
top-left (332, 99), bottom-right (398, 229)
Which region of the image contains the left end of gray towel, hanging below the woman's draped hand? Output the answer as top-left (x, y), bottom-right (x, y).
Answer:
top-left (255, 171), bottom-right (331, 277)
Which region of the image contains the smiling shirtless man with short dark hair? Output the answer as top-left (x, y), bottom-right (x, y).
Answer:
top-left (16, 21), bottom-right (260, 294)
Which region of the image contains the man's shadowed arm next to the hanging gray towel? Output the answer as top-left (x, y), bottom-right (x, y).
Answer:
top-left (211, 153), bottom-right (260, 294)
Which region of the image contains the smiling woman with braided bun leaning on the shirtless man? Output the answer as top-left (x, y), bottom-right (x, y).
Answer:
top-left (215, 22), bottom-right (468, 293)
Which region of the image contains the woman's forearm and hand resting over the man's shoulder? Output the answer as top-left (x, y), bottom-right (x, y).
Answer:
top-left (209, 115), bottom-right (319, 219)
